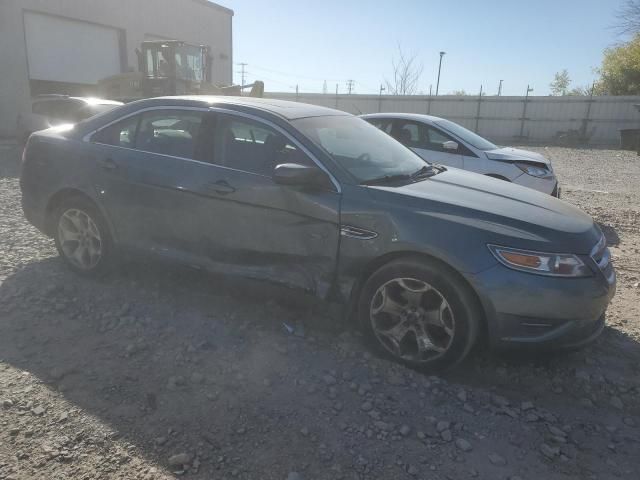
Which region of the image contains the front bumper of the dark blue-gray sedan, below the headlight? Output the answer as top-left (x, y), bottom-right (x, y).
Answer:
top-left (468, 265), bottom-right (616, 348)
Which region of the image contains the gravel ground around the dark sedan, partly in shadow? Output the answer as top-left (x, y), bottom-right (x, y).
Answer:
top-left (0, 144), bottom-right (640, 480)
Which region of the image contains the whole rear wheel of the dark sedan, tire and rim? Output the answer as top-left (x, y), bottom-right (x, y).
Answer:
top-left (52, 196), bottom-right (115, 276)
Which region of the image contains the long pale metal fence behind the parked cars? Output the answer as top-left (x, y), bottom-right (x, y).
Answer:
top-left (265, 92), bottom-right (640, 145)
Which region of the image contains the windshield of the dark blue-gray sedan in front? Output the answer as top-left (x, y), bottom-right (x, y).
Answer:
top-left (292, 115), bottom-right (426, 183)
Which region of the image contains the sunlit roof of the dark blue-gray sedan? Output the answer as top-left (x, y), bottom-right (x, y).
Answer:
top-left (157, 95), bottom-right (351, 120)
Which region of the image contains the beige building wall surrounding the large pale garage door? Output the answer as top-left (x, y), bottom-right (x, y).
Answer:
top-left (0, 0), bottom-right (233, 136)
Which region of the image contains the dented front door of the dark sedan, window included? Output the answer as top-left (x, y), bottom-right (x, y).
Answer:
top-left (191, 113), bottom-right (340, 297)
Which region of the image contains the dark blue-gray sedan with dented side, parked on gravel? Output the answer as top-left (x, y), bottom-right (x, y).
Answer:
top-left (21, 97), bottom-right (615, 369)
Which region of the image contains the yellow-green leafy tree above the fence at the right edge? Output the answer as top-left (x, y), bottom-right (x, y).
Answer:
top-left (595, 33), bottom-right (640, 95)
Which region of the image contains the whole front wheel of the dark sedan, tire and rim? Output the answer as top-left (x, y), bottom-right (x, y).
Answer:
top-left (358, 257), bottom-right (482, 372)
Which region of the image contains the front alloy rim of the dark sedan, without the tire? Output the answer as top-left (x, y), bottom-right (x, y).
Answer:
top-left (369, 278), bottom-right (455, 363)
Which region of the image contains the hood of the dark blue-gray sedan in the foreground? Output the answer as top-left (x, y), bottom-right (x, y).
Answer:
top-left (369, 168), bottom-right (601, 255)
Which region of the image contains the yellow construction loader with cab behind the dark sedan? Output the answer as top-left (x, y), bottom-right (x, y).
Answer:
top-left (98, 40), bottom-right (264, 102)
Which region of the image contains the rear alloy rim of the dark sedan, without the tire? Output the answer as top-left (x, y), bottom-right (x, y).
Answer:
top-left (58, 208), bottom-right (103, 270)
